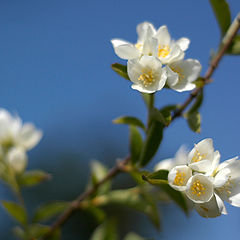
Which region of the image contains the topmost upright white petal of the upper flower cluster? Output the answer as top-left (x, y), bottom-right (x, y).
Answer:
top-left (137, 22), bottom-right (156, 43)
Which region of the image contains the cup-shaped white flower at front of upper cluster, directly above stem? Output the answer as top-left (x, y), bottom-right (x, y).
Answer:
top-left (127, 55), bottom-right (167, 93)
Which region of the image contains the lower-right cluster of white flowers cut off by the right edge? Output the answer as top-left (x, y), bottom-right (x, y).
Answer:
top-left (157, 139), bottom-right (240, 218)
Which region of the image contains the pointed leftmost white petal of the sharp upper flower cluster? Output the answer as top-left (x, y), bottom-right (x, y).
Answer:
top-left (111, 39), bottom-right (141, 60)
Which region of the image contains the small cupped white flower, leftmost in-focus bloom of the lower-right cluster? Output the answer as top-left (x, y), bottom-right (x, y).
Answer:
top-left (168, 165), bottom-right (192, 191)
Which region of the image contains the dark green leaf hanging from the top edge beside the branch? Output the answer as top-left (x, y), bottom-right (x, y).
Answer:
top-left (210, 0), bottom-right (231, 36)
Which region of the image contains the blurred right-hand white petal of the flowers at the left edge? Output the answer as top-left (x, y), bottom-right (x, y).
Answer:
top-left (18, 123), bottom-right (42, 150)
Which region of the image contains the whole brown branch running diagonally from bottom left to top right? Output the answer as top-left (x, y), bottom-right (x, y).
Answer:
top-left (42, 11), bottom-right (240, 239)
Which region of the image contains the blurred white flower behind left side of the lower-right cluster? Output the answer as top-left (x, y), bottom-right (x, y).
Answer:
top-left (154, 145), bottom-right (188, 171)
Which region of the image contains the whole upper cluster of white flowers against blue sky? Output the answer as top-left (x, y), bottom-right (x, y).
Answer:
top-left (111, 22), bottom-right (201, 93)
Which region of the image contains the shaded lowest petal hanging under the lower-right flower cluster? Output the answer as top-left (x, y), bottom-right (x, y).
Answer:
top-left (195, 194), bottom-right (227, 218)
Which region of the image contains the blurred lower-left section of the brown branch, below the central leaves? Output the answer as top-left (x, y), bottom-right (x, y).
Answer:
top-left (42, 157), bottom-right (130, 239)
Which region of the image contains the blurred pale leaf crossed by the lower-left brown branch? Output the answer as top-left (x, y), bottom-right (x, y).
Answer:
top-left (91, 160), bottom-right (111, 195)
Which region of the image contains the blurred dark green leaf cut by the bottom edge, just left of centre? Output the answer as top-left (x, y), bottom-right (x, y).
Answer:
top-left (90, 220), bottom-right (119, 240)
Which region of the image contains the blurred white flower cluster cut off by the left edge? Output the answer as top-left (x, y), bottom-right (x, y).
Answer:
top-left (0, 109), bottom-right (42, 173)
